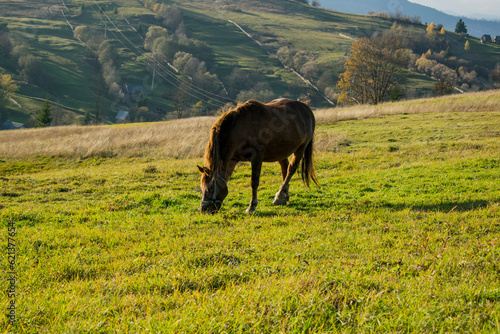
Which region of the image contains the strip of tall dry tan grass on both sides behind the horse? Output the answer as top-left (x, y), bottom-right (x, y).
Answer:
top-left (0, 90), bottom-right (500, 158)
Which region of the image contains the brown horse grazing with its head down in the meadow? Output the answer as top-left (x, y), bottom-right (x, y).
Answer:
top-left (198, 99), bottom-right (318, 213)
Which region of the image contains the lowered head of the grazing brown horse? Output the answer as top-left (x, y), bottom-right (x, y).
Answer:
top-left (198, 166), bottom-right (228, 213)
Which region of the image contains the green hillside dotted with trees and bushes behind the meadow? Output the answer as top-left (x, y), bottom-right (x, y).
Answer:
top-left (0, 0), bottom-right (500, 126)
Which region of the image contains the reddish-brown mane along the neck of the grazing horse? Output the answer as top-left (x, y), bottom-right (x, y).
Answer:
top-left (204, 100), bottom-right (265, 173)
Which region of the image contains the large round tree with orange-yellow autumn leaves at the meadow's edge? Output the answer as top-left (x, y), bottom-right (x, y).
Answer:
top-left (337, 33), bottom-right (409, 104)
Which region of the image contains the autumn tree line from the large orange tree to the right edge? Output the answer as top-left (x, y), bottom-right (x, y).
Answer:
top-left (336, 19), bottom-right (500, 104)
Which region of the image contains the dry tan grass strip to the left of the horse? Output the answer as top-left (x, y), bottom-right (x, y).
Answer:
top-left (0, 117), bottom-right (215, 158)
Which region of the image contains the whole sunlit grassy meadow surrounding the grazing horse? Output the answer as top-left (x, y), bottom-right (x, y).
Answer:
top-left (0, 92), bottom-right (500, 333)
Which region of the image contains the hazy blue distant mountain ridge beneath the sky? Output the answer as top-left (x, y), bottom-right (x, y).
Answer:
top-left (321, 0), bottom-right (500, 37)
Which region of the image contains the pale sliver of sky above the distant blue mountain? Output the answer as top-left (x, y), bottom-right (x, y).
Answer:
top-left (410, 0), bottom-right (500, 20)
